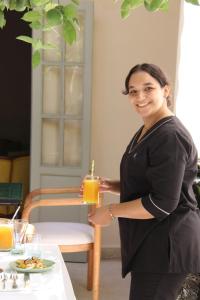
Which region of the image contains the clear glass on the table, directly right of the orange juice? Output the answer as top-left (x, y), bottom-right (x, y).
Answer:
top-left (11, 219), bottom-right (28, 254)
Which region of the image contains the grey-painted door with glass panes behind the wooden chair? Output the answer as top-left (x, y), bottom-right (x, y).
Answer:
top-left (31, 0), bottom-right (93, 239)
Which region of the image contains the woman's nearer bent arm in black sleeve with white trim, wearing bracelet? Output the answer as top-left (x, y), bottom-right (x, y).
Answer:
top-left (89, 132), bottom-right (190, 226)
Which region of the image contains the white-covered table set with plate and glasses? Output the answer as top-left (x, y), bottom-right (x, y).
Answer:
top-left (0, 244), bottom-right (76, 300)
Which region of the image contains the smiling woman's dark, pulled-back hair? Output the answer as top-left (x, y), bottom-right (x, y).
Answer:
top-left (122, 63), bottom-right (171, 106)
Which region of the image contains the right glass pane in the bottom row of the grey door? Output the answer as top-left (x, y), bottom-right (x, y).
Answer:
top-left (64, 120), bottom-right (81, 166)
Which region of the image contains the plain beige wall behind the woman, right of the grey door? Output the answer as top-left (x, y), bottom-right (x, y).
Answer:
top-left (91, 0), bottom-right (181, 247)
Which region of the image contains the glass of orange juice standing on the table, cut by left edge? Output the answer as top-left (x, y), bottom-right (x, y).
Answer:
top-left (0, 219), bottom-right (14, 251)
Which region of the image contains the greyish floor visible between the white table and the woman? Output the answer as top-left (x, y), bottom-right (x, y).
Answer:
top-left (66, 259), bottom-right (130, 300)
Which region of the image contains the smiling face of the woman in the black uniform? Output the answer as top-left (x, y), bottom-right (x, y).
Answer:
top-left (129, 71), bottom-right (169, 118)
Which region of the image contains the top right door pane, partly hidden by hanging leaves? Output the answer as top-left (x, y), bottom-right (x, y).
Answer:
top-left (65, 15), bottom-right (84, 62)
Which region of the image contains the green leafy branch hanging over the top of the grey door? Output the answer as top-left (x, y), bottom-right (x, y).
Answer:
top-left (0, 0), bottom-right (79, 67)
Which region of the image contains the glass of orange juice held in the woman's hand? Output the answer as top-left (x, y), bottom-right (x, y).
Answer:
top-left (83, 175), bottom-right (100, 204)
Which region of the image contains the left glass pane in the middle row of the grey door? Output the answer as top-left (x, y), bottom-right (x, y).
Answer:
top-left (43, 67), bottom-right (61, 113)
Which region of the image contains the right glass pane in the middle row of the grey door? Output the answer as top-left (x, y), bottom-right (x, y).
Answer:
top-left (65, 67), bottom-right (83, 115)
